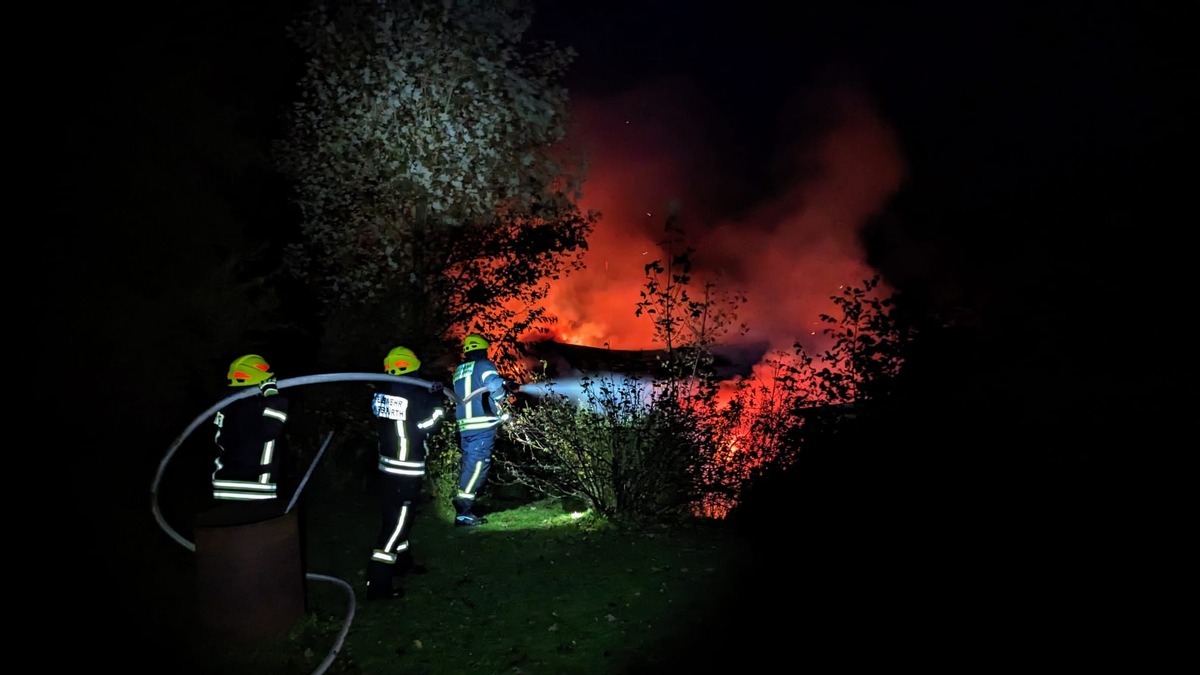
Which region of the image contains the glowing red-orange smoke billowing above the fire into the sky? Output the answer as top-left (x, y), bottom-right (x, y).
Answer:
top-left (532, 74), bottom-right (904, 362)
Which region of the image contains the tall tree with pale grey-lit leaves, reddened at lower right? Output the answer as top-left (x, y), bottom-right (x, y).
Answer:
top-left (278, 0), bottom-right (599, 367)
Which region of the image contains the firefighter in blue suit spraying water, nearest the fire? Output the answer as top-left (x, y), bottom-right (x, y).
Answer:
top-left (452, 333), bottom-right (509, 527)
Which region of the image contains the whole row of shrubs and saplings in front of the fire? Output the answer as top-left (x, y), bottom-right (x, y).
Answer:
top-left (498, 216), bottom-right (913, 522)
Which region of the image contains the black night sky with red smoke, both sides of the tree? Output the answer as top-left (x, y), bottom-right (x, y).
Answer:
top-left (29, 1), bottom-right (1194, 369)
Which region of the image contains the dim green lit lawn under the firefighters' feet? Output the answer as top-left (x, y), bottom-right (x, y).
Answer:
top-left (126, 473), bottom-right (742, 675)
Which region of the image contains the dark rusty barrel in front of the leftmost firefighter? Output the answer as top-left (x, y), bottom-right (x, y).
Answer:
top-left (196, 500), bottom-right (306, 641)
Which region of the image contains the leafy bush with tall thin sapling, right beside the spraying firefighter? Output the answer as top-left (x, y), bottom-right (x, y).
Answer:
top-left (496, 217), bottom-right (744, 522)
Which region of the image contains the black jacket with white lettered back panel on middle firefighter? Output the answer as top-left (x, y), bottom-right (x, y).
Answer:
top-left (371, 382), bottom-right (445, 477)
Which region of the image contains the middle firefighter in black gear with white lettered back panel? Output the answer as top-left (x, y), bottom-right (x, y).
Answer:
top-left (367, 346), bottom-right (445, 599)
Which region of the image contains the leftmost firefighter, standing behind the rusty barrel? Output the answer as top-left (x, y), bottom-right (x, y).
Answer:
top-left (212, 354), bottom-right (288, 504)
